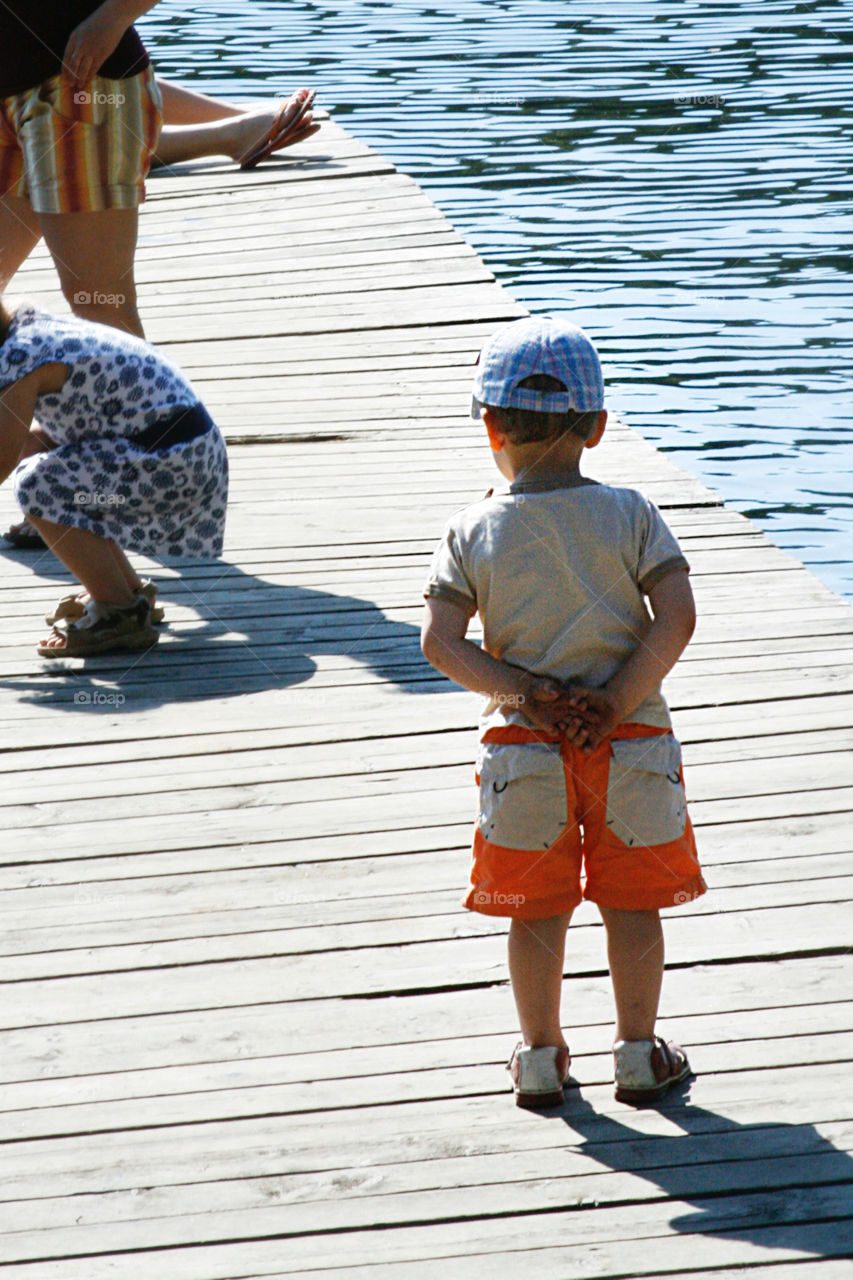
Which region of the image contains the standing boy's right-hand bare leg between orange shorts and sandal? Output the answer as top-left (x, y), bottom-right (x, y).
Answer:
top-left (598, 906), bottom-right (663, 1039)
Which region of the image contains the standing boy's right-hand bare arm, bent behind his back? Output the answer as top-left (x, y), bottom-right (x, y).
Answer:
top-left (567, 570), bottom-right (695, 751)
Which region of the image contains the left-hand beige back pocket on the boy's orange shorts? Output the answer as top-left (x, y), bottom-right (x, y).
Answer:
top-left (478, 742), bottom-right (567, 850)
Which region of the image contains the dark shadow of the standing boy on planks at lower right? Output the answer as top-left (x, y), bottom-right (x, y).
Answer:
top-left (552, 1085), bottom-right (853, 1257)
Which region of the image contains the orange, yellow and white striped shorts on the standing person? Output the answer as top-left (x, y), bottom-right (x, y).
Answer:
top-left (0, 67), bottom-right (163, 214)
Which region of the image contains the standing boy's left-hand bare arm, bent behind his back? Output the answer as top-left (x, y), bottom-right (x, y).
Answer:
top-left (420, 596), bottom-right (578, 732)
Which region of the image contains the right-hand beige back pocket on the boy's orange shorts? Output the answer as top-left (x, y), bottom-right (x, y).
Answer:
top-left (606, 733), bottom-right (686, 846)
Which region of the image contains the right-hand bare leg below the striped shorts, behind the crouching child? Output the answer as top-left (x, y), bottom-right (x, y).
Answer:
top-left (38, 209), bottom-right (145, 338)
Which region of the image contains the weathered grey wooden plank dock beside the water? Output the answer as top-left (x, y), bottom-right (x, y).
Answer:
top-left (0, 115), bottom-right (853, 1280)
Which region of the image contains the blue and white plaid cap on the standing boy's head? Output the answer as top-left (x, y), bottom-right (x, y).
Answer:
top-left (471, 316), bottom-right (605, 417)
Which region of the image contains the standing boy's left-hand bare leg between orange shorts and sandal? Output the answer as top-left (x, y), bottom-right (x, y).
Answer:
top-left (507, 911), bottom-right (571, 1048)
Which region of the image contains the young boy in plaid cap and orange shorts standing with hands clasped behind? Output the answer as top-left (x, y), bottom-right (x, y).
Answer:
top-left (421, 316), bottom-right (704, 1107)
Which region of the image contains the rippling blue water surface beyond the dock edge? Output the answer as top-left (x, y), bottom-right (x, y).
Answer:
top-left (140, 0), bottom-right (853, 598)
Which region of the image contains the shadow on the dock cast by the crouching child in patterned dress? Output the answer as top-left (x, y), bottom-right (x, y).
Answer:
top-left (0, 552), bottom-right (453, 713)
